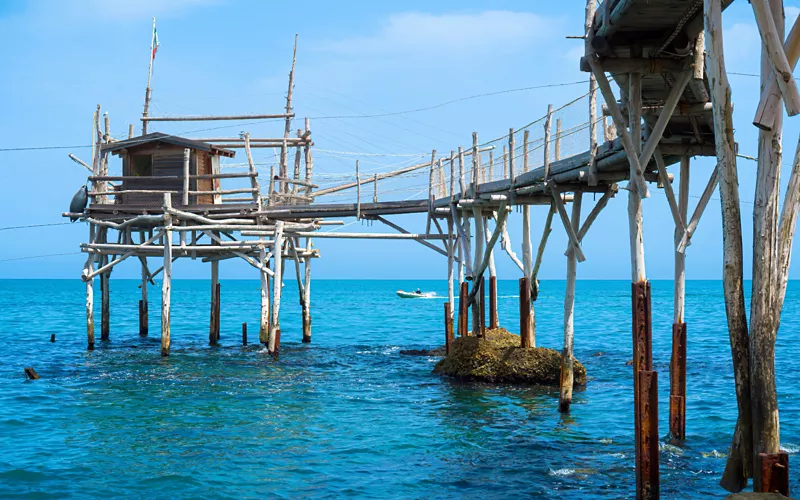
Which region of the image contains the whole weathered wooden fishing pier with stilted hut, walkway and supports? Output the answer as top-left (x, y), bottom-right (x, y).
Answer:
top-left (64, 0), bottom-right (800, 498)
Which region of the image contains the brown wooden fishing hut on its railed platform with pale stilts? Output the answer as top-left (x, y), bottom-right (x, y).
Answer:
top-left (63, 37), bottom-right (321, 357)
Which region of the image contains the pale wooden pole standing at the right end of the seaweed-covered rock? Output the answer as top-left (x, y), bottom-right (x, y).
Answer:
top-left (558, 191), bottom-right (583, 413)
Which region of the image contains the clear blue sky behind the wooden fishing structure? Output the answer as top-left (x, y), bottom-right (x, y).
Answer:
top-left (0, 0), bottom-right (800, 279)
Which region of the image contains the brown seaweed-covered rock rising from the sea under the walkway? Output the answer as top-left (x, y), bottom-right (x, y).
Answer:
top-left (433, 328), bottom-right (586, 386)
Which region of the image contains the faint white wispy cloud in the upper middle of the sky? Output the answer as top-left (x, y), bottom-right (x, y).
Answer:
top-left (320, 11), bottom-right (558, 63)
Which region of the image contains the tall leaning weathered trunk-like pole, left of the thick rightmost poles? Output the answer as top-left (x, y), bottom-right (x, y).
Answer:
top-left (704, 0), bottom-right (754, 491)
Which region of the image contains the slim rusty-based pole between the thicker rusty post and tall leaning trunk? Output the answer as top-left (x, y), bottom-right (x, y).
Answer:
top-left (669, 156), bottom-right (689, 441)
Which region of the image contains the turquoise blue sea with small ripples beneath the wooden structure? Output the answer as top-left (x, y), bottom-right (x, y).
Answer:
top-left (0, 278), bottom-right (800, 499)
